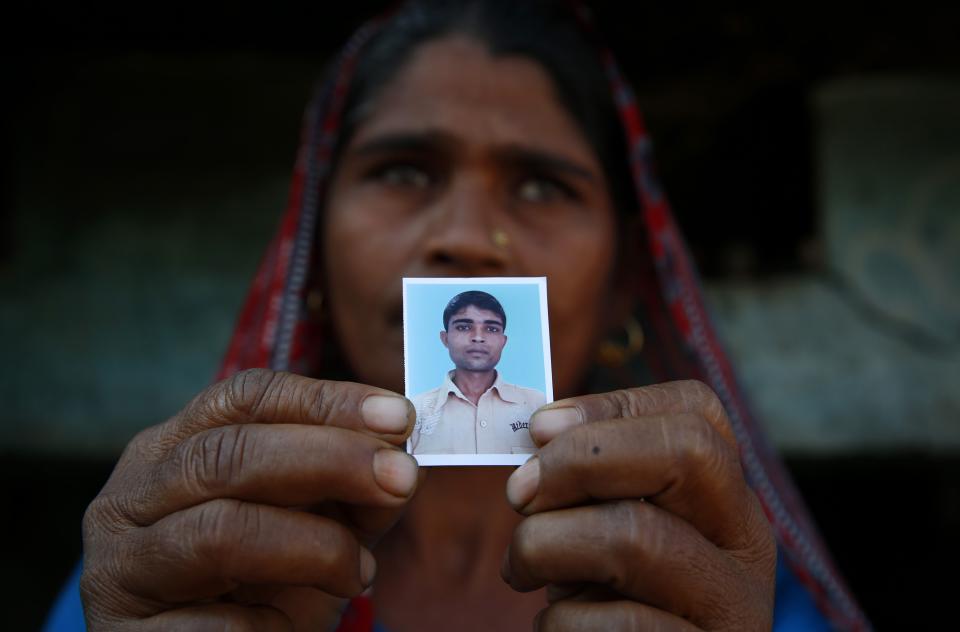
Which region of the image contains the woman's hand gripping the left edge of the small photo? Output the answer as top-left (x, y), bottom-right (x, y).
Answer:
top-left (80, 369), bottom-right (417, 632)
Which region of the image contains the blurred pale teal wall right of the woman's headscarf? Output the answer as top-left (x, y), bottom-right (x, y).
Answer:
top-left (708, 76), bottom-right (960, 454)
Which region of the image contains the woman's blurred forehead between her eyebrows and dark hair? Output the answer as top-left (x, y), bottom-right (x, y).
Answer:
top-left (351, 35), bottom-right (596, 166)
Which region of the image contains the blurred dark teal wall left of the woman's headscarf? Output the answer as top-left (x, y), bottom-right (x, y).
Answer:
top-left (0, 54), bottom-right (317, 457)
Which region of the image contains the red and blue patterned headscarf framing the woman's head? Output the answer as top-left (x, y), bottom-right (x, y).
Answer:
top-left (218, 6), bottom-right (870, 630)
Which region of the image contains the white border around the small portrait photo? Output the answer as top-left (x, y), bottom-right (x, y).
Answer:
top-left (403, 277), bottom-right (553, 466)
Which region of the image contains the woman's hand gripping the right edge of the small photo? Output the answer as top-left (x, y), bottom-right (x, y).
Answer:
top-left (502, 382), bottom-right (776, 631)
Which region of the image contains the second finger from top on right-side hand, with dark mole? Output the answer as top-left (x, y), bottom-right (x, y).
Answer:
top-left (507, 413), bottom-right (769, 549)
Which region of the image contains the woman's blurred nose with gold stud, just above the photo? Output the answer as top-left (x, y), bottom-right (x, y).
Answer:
top-left (424, 176), bottom-right (511, 276)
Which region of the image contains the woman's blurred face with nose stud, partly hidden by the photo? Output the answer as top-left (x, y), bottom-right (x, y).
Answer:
top-left (323, 36), bottom-right (616, 396)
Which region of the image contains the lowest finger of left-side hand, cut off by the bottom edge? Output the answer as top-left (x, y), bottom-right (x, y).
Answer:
top-left (136, 603), bottom-right (294, 632)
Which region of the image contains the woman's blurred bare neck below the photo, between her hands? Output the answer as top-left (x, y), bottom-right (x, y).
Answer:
top-left (374, 467), bottom-right (546, 631)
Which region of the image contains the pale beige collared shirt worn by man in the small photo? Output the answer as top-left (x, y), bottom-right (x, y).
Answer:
top-left (411, 371), bottom-right (546, 454)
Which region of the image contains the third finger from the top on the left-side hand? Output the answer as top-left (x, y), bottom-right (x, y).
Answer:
top-left (111, 499), bottom-right (376, 604)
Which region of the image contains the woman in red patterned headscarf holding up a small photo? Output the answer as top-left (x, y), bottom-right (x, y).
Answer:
top-left (56, 1), bottom-right (869, 631)
